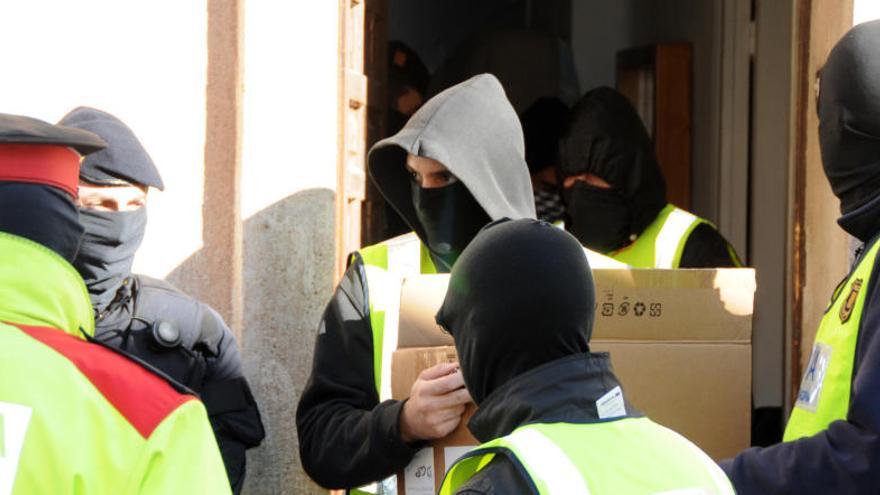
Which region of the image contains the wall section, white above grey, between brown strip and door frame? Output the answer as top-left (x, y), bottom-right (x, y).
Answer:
top-left (241, 1), bottom-right (339, 495)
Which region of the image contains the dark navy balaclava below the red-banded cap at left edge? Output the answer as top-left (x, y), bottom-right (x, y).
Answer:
top-left (0, 181), bottom-right (83, 262)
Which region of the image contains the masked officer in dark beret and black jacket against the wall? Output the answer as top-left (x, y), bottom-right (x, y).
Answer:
top-left (60, 107), bottom-right (264, 493)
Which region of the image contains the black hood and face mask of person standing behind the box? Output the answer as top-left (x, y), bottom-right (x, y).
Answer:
top-left (560, 87), bottom-right (666, 252)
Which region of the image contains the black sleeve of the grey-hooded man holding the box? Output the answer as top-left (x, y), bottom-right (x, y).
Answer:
top-left (296, 257), bottom-right (418, 488)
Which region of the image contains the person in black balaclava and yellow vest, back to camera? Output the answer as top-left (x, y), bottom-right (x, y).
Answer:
top-left (437, 220), bottom-right (733, 495)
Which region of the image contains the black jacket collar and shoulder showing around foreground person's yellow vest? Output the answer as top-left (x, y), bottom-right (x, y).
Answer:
top-left (456, 353), bottom-right (641, 495)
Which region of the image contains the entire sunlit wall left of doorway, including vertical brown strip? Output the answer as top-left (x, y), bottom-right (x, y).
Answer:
top-left (0, 0), bottom-right (339, 494)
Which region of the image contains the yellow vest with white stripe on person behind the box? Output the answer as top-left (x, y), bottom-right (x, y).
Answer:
top-left (609, 204), bottom-right (711, 269)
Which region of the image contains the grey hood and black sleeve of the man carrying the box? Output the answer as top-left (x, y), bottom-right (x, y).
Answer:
top-left (296, 74), bottom-right (535, 488)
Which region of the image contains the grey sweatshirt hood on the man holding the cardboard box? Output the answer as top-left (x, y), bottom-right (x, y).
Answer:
top-left (368, 74), bottom-right (535, 264)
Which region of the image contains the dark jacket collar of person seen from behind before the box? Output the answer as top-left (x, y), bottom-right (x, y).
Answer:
top-left (468, 352), bottom-right (642, 442)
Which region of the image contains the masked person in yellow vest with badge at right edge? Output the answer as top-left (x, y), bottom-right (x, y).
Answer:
top-left (722, 21), bottom-right (880, 495)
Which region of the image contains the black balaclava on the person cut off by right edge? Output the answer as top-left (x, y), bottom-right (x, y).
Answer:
top-left (818, 21), bottom-right (880, 241)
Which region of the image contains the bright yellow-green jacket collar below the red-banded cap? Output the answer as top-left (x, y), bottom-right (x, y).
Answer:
top-left (0, 232), bottom-right (95, 338)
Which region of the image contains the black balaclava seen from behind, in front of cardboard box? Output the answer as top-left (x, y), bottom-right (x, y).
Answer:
top-left (437, 219), bottom-right (595, 405)
